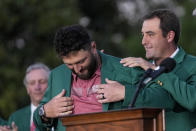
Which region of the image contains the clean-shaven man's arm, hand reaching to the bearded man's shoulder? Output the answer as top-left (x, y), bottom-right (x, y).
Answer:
top-left (121, 57), bottom-right (196, 111)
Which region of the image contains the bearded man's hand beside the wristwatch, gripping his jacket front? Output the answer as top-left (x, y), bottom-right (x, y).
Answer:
top-left (44, 89), bottom-right (74, 118)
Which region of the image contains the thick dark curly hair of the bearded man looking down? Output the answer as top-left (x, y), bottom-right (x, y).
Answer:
top-left (54, 25), bottom-right (91, 57)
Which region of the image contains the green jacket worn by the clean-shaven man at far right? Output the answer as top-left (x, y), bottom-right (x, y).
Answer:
top-left (159, 48), bottom-right (196, 131)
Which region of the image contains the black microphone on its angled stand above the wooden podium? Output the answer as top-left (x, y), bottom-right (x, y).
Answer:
top-left (130, 58), bottom-right (176, 108)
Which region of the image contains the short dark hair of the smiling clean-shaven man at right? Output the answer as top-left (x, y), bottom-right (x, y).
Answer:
top-left (143, 9), bottom-right (180, 44)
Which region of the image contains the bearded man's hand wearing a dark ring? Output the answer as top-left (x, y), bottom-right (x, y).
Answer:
top-left (97, 78), bottom-right (125, 103)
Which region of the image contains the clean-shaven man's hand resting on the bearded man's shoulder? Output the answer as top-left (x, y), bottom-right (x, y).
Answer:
top-left (120, 57), bottom-right (156, 70)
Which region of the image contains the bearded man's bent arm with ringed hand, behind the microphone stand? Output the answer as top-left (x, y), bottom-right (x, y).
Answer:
top-left (97, 80), bottom-right (175, 109)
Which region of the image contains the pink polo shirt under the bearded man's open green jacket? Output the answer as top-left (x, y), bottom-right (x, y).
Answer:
top-left (71, 66), bottom-right (103, 114)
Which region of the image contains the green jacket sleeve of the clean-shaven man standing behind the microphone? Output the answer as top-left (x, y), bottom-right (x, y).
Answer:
top-left (159, 73), bottom-right (196, 111)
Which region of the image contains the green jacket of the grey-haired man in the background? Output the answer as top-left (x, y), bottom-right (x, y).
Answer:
top-left (8, 105), bottom-right (31, 131)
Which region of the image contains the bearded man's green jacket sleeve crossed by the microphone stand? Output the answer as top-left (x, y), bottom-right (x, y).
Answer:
top-left (123, 81), bottom-right (175, 110)
